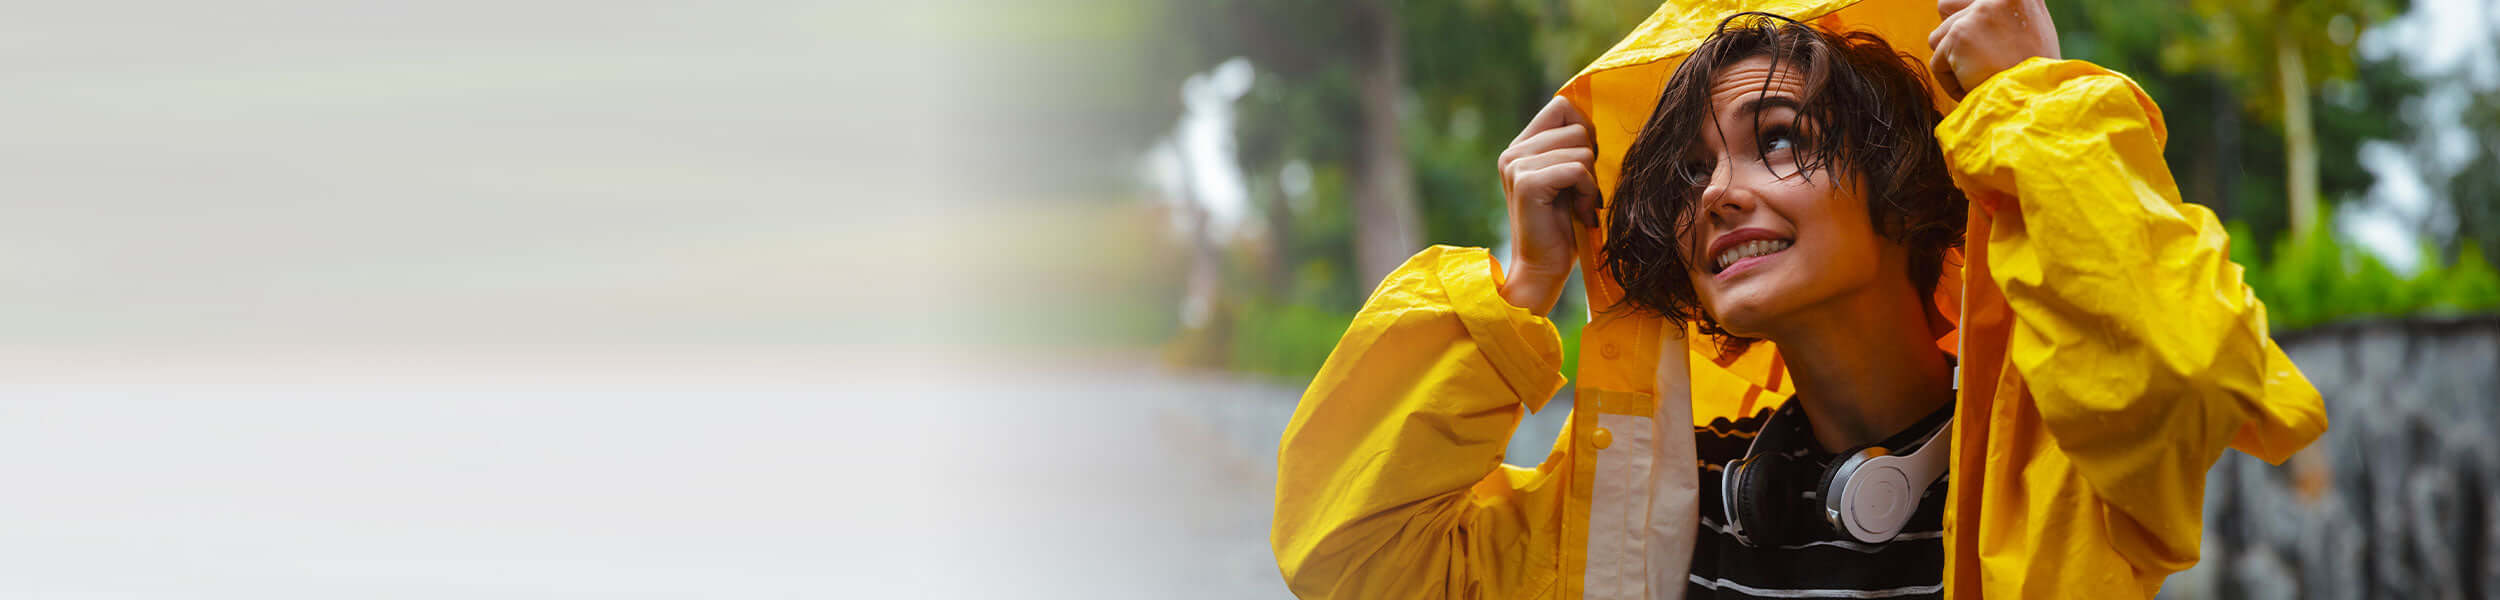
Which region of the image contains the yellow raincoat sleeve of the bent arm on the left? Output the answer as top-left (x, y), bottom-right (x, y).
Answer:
top-left (1270, 245), bottom-right (1568, 598)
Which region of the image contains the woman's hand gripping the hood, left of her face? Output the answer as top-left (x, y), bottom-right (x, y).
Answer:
top-left (1495, 95), bottom-right (1600, 315)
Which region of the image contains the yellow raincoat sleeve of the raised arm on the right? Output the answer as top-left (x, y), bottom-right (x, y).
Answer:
top-left (1938, 58), bottom-right (2325, 573)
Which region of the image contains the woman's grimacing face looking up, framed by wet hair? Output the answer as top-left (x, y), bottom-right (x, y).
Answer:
top-left (1680, 58), bottom-right (1908, 340)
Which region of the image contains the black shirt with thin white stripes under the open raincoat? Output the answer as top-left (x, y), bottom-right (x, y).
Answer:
top-left (1685, 400), bottom-right (1953, 598)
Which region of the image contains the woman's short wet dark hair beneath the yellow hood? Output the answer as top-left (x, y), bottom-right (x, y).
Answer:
top-left (1600, 13), bottom-right (1968, 353)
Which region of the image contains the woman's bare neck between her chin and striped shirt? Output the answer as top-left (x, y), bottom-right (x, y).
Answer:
top-left (1770, 290), bottom-right (1953, 453)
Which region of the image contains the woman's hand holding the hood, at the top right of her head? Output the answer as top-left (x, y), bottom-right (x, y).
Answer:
top-left (1928, 0), bottom-right (2060, 100)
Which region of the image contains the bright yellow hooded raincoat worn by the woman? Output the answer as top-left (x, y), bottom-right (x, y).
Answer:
top-left (1270, 0), bottom-right (2328, 600)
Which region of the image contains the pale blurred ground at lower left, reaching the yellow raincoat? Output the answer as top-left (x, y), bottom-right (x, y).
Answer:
top-left (0, 353), bottom-right (1295, 598)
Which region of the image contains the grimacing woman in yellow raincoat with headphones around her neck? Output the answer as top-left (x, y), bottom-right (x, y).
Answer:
top-left (1273, 0), bottom-right (2325, 598)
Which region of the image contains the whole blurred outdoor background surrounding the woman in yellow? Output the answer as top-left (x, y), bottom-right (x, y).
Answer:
top-left (0, 0), bottom-right (2500, 598)
